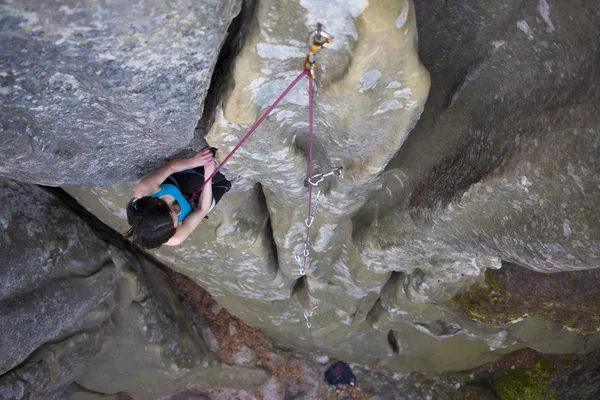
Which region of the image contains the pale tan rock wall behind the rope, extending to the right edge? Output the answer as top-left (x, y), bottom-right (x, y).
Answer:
top-left (68, 0), bottom-right (600, 371)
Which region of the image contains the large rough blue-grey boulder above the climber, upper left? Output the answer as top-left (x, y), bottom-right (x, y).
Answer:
top-left (0, 0), bottom-right (241, 186)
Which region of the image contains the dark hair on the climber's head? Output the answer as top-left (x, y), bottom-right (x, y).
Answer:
top-left (125, 196), bottom-right (176, 249)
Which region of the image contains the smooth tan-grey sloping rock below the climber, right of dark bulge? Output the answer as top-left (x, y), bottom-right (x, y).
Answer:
top-left (76, 248), bottom-right (218, 399)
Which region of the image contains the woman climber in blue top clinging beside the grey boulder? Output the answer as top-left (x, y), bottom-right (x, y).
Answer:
top-left (126, 148), bottom-right (231, 249)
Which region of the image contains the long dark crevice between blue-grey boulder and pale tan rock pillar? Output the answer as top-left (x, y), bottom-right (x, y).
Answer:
top-left (195, 0), bottom-right (258, 140)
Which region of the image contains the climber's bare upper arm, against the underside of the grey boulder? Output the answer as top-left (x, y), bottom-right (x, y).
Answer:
top-left (133, 147), bottom-right (214, 199)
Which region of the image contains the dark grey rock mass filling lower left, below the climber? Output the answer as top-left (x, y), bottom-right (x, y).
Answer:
top-left (0, 179), bottom-right (268, 400)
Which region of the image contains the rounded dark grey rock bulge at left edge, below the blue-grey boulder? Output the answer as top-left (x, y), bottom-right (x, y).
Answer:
top-left (0, 179), bottom-right (116, 373)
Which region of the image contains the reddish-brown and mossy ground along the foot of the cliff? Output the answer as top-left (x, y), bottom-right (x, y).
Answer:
top-left (127, 271), bottom-right (600, 400)
